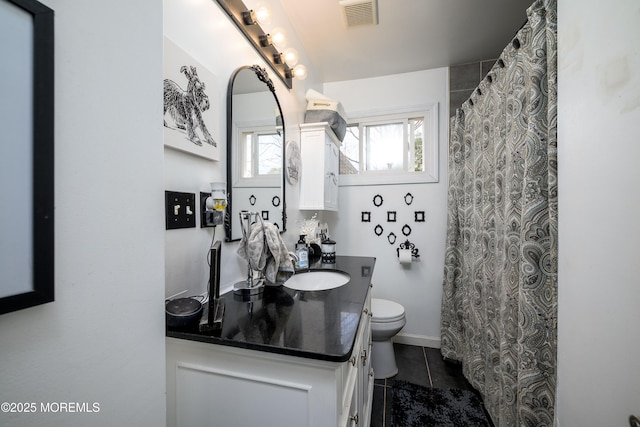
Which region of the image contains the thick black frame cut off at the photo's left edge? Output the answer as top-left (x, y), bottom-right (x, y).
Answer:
top-left (0, 0), bottom-right (54, 314)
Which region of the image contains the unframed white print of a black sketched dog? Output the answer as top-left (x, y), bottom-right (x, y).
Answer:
top-left (163, 37), bottom-right (221, 160)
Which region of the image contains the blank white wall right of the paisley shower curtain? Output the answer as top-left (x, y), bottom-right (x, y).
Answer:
top-left (557, 0), bottom-right (640, 427)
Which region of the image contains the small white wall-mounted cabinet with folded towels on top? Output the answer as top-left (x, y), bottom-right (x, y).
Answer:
top-left (300, 123), bottom-right (340, 211)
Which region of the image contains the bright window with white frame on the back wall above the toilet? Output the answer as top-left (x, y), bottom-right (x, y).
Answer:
top-left (340, 105), bottom-right (438, 185)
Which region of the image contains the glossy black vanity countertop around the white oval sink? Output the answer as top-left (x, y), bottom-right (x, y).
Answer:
top-left (166, 256), bottom-right (376, 362)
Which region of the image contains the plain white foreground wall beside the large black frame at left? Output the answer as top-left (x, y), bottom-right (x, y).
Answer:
top-left (0, 0), bottom-right (165, 427)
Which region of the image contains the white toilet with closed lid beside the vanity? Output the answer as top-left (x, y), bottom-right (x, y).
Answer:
top-left (371, 298), bottom-right (406, 379)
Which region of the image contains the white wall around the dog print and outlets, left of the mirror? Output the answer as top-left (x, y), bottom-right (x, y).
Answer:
top-left (164, 0), bottom-right (252, 296)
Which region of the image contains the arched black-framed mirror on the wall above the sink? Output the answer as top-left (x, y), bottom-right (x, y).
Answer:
top-left (224, 65), bottom-right (287, 242)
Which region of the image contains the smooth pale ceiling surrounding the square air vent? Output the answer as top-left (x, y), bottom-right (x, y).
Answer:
top-left (280, 0), bottom-right (533, 82)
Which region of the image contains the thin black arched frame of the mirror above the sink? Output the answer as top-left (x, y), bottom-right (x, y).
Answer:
top-left (224, 65), bottom-right (287, 242)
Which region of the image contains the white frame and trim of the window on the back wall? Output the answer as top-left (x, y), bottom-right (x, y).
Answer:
top-left (339, 103), bottom-right (440, 187)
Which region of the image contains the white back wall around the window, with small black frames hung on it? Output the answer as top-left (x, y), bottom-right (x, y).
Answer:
top-left (322, 68), bottom-right (449, 347)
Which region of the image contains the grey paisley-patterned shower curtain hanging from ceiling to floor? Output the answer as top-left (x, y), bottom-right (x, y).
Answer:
top-left (441, 0), bottom-right (558, 427)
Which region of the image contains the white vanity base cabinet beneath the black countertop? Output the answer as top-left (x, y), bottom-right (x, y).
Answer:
top-left (167, 291), bottom-right (373, 427)
